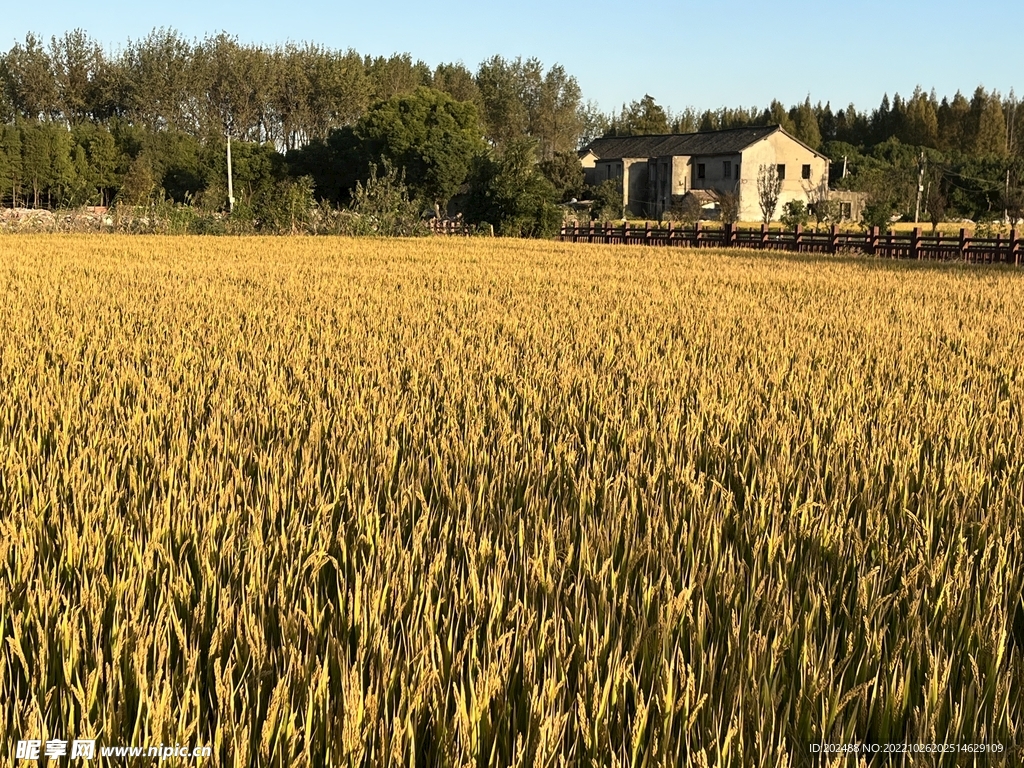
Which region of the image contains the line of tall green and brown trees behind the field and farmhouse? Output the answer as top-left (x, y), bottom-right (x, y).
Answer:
top-left (0, 29), bottom-right (1024, 233)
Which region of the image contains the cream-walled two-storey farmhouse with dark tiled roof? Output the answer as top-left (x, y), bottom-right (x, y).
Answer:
top-left (580, 125), bottom-right (828, 221)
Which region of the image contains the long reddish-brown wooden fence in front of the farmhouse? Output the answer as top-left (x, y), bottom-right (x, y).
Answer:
top-left (559, 221), bottom-right (1024, 266)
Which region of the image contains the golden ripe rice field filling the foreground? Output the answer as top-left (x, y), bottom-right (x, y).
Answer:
top-left (0, 236), bottom-right (1024, 768)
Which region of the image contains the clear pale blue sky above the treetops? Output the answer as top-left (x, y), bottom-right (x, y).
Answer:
top-left (0, 0), bottom-right (1024, 111)
